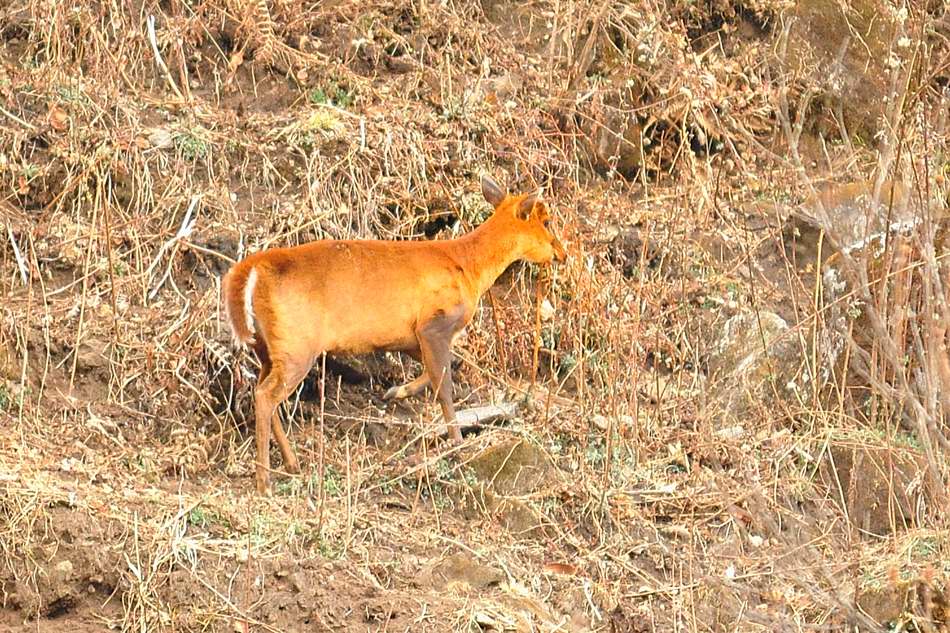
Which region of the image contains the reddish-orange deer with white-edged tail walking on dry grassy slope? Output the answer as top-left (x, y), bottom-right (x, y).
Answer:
top-left (222, 175), bottom-right (566, 495)
